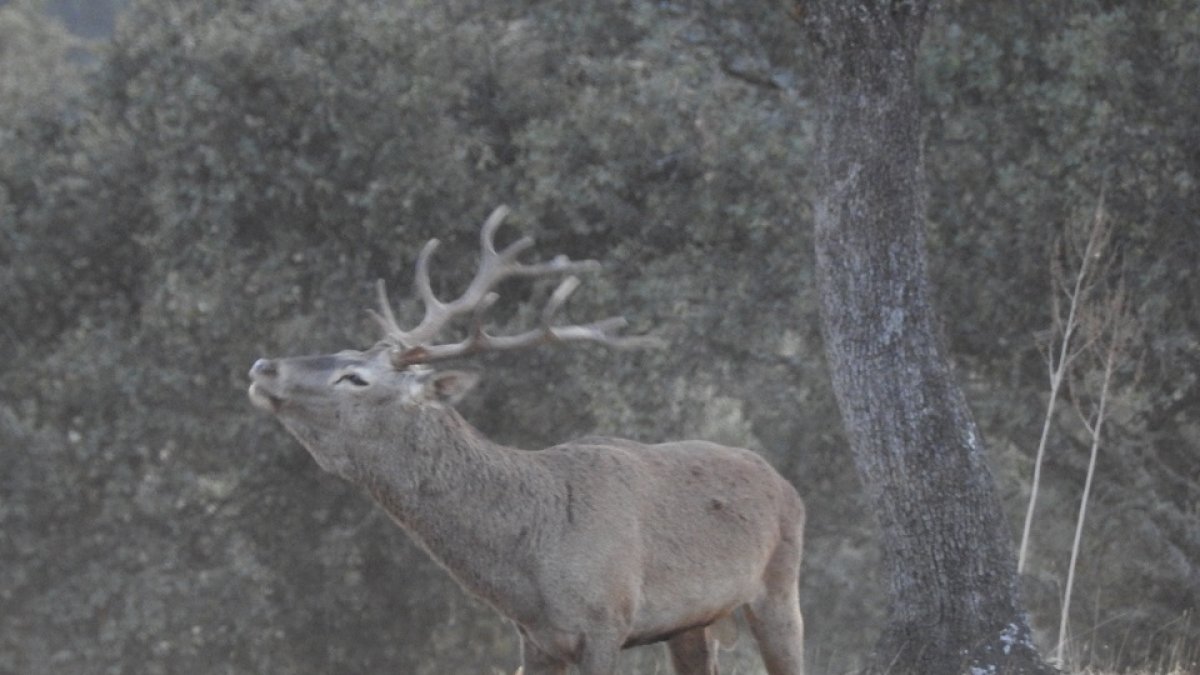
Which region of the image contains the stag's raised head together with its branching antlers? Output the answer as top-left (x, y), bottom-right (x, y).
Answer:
top-left (250, 201), bottom-right (655, 473)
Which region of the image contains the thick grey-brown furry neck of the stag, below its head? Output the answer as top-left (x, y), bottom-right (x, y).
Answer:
top-left (354, 401), bottom-right (556, 615)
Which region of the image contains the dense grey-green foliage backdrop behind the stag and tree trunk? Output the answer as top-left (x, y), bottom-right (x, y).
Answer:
top-left (0, 0), bottom-right (1200, 675)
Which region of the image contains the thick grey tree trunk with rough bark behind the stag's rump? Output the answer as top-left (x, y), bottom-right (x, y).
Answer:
top-left (798, 0), bottom-right (1052, 675)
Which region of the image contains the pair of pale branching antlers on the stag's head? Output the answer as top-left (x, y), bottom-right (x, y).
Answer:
top-left (371, 207), bottom-right (660, 368)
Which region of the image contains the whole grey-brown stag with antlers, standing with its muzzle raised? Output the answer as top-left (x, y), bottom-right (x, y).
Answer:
top-left (250, 207), bottom-right (804, 675)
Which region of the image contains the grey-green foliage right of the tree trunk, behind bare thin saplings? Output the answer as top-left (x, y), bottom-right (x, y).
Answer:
top-left (924, 2), bottom-right (1200, 664)
